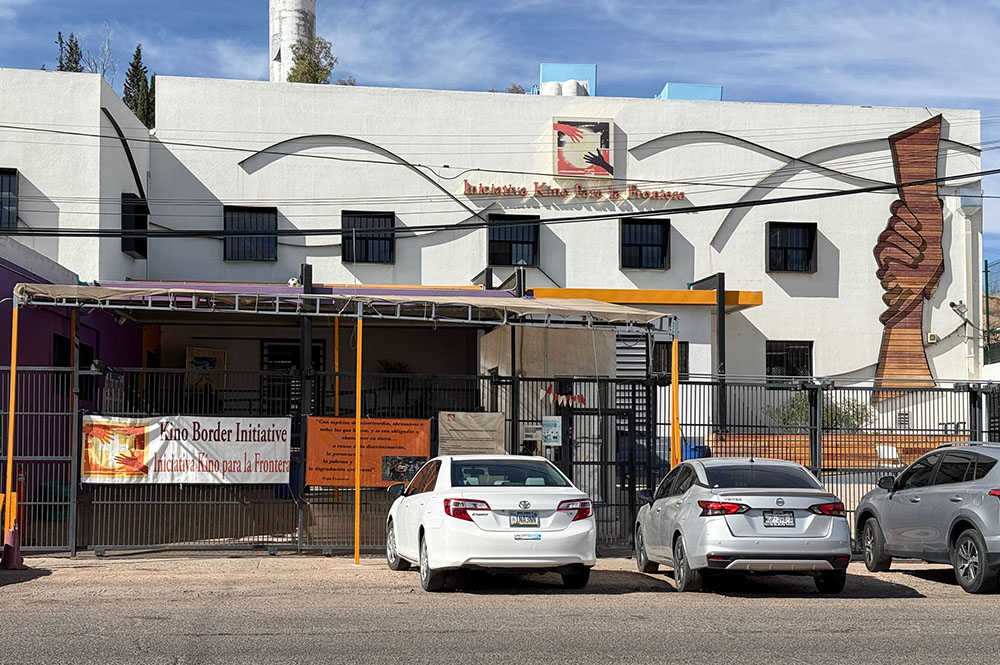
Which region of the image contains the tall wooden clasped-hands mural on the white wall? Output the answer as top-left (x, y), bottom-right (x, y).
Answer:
top-left (875, 115), bottom-right (944, 397)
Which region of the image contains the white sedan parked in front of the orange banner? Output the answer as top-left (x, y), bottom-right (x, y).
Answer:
top-left (385, 455), bottom-right (597, 591)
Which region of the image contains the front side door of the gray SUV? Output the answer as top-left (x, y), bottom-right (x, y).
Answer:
top-left (882, 453), bottom-right (942, 556)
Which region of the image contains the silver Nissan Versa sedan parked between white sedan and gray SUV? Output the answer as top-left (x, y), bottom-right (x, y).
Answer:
top-left (635, 457), bottom-right (851, 593)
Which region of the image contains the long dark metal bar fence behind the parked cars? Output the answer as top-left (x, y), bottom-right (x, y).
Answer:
top-left (0, 368), bottom-right (1000, 552)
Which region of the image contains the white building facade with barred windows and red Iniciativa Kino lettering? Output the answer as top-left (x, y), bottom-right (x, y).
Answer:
top-left (0, 69), bottom-right (982, 379)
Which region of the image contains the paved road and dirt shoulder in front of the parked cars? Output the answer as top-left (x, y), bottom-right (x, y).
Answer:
top-left (0, 554), bottom-right (1000, 665)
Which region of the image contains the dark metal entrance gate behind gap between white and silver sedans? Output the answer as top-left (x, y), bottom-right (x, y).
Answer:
top-left (560, 408), bottom-right (645, 551)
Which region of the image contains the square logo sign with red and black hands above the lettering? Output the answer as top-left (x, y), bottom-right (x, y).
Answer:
top-left (552, 118), bottom-right (615, 178)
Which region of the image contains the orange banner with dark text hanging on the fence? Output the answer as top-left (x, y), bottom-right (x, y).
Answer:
top-left (306, 418), bottom-right (431, 487)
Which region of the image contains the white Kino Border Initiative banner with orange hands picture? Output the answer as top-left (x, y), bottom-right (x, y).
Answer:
top-left (81, 416), bottom-right (292, 484)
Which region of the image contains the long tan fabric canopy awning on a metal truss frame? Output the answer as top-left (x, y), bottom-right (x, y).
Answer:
top-left (14, 282), bottom-right (670, 327)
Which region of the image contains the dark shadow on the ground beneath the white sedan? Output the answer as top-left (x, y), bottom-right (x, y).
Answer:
top-left (438, 570), bottom-right (673, 595)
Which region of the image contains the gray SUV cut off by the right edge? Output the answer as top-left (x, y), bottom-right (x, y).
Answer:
top-left (856, 441), bottom-right (1000, 593)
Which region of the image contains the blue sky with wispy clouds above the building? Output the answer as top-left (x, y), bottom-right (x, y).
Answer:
top-left (0, 0), bottom-right (1000, 252)
